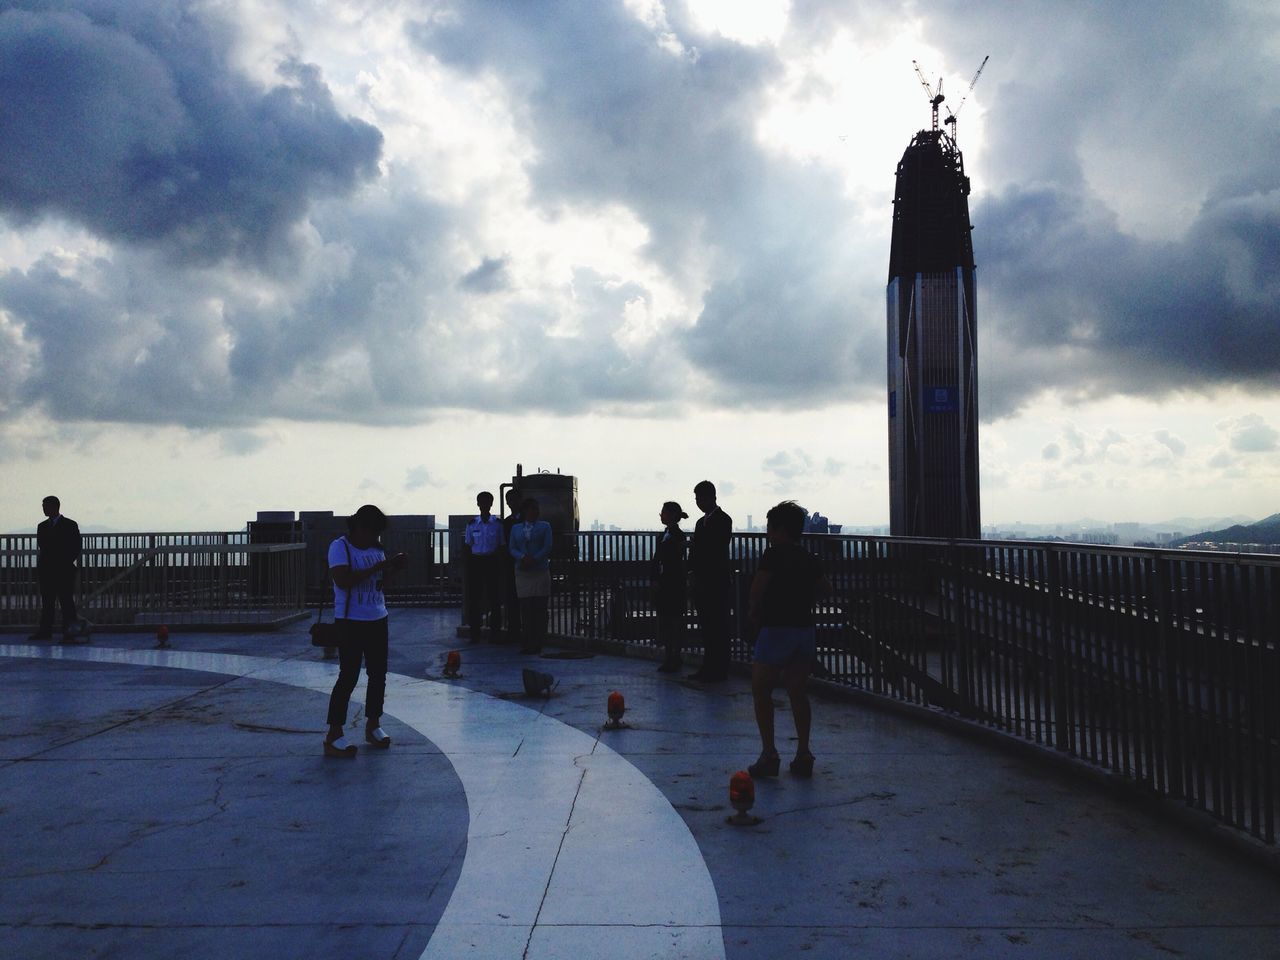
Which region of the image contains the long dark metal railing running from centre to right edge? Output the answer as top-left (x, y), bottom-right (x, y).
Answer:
top-left (524, 532), bottom-right (1280, 845)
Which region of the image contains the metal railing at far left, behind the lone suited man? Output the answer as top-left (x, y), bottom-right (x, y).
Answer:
top-left (0, 532), bottom-right (305, 630)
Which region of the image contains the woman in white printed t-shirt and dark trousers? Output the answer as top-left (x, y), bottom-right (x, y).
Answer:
top-left (324, 503), bottom-right (408, 756)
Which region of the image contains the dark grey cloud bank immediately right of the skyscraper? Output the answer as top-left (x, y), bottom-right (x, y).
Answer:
top-left (977, 176), bottom-right (1280, 416)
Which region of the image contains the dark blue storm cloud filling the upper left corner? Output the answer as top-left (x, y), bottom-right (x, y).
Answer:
top-left (0, 0), bottom-right (381, 261)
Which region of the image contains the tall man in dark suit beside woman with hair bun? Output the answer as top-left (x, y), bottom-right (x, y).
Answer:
top-left (689, 480), bottom-right (733, 684)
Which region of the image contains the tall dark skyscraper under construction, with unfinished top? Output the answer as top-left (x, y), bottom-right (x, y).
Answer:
top-left (888, 69), bottom-right (986, 539)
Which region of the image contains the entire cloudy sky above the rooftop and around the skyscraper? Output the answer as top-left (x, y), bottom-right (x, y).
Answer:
top-left (0, 0), bottom-right (1280, 530)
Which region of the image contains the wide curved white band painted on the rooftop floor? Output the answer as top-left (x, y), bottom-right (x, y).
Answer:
top-left (0, 644), bottom-right (724, 960)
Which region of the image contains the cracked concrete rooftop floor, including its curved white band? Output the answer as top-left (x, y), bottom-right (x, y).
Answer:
top-left (0, 611), bottom-right (1280, 960)
